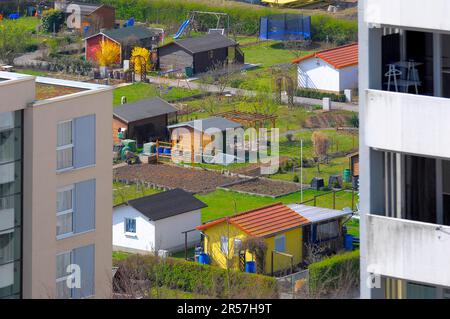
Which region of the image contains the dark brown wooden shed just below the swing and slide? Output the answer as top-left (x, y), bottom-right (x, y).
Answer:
top-left (158, 33), bottom-right (244, 74)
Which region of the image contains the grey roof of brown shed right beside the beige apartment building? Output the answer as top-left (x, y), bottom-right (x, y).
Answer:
top-left (113, 97), bottom-right (177, 123)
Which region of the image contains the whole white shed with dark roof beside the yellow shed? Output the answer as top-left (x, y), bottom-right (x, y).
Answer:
top-left (113, 189), bottom-right (206, 253)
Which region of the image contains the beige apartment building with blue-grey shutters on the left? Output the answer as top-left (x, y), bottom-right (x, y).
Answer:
top-left (0, 72), bottom-right (112, 298)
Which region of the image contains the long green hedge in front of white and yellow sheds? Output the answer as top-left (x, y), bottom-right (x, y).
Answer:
top-left (117, 255), bottom-right (277, 299)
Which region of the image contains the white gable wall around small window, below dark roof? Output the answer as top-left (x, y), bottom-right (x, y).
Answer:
top-left (112, 205), bottom-right (155, 253)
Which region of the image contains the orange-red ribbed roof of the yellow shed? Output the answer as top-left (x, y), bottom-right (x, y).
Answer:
top-left (197, 203), bottom-right (309, 237)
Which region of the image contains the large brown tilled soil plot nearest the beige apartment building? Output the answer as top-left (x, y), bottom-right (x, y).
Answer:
top-left (114, 164), bottom-right (241, 193)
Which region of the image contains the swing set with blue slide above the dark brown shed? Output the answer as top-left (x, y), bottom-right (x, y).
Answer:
top-left (173, 11), bottom-right (230, 40)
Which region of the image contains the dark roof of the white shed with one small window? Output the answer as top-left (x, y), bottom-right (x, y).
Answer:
top-left (128, 188), bottom-right (207, 220)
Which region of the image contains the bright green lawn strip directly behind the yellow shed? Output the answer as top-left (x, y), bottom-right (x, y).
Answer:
top-left (196, 189), bottom-right (356, 222)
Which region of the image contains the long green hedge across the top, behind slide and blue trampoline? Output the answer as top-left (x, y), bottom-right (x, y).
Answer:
top-left (97, 0), bottom-right (358, 45)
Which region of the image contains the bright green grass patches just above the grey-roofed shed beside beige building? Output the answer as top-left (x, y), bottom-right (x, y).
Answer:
top-left (113, 82), bottom-right (200, 106)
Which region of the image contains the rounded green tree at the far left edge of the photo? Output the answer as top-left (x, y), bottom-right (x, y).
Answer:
top-left (0, 23), bottom-right (30, 64)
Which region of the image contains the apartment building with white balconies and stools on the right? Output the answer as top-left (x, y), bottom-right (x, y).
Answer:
top-left (359, 0), bottom-right (450, 299)
